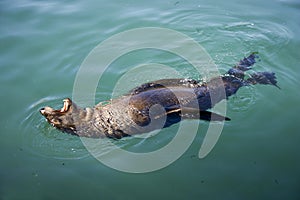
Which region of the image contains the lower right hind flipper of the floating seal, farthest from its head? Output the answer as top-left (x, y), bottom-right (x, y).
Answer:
top-left (246, 72), bottom-right (280, 89)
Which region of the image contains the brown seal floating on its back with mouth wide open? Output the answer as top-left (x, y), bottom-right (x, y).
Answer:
top-left (40, 53), bottom-right (279, 139)
